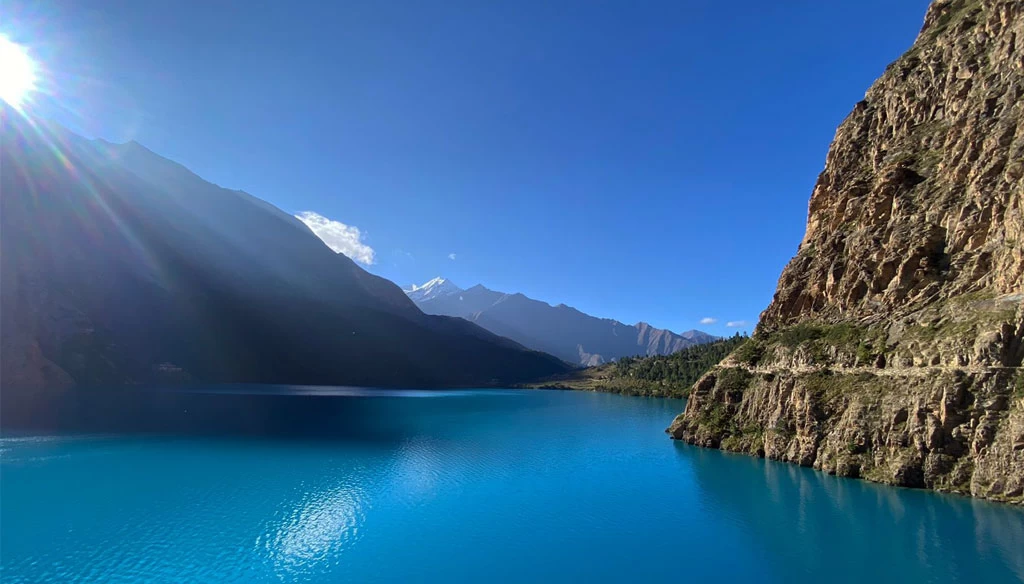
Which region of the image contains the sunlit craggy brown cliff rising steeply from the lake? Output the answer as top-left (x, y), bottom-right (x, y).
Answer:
top-left (669, 0), bottom-right (1024, 502)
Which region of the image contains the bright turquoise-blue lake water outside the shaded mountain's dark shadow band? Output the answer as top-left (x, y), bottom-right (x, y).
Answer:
top-left (0, 391), bottom-right (1024, 584)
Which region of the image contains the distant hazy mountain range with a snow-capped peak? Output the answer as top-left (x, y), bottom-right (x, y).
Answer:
top-left (406, 278), bottom-right (716, 367)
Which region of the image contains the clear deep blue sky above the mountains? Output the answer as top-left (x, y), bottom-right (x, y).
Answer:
top-left (6, 0), bottom-right (928, 334)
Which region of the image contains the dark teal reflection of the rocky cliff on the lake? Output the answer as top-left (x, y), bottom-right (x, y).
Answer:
top-left (676, 444), bottom-right (1024, 582)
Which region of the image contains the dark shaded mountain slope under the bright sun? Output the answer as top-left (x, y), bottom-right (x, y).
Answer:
top-left (0, 107), bottom-right (566, 390)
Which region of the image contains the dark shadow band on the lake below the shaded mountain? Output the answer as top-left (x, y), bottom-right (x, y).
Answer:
top-left (0, 385), bottom-right (540, 444)
